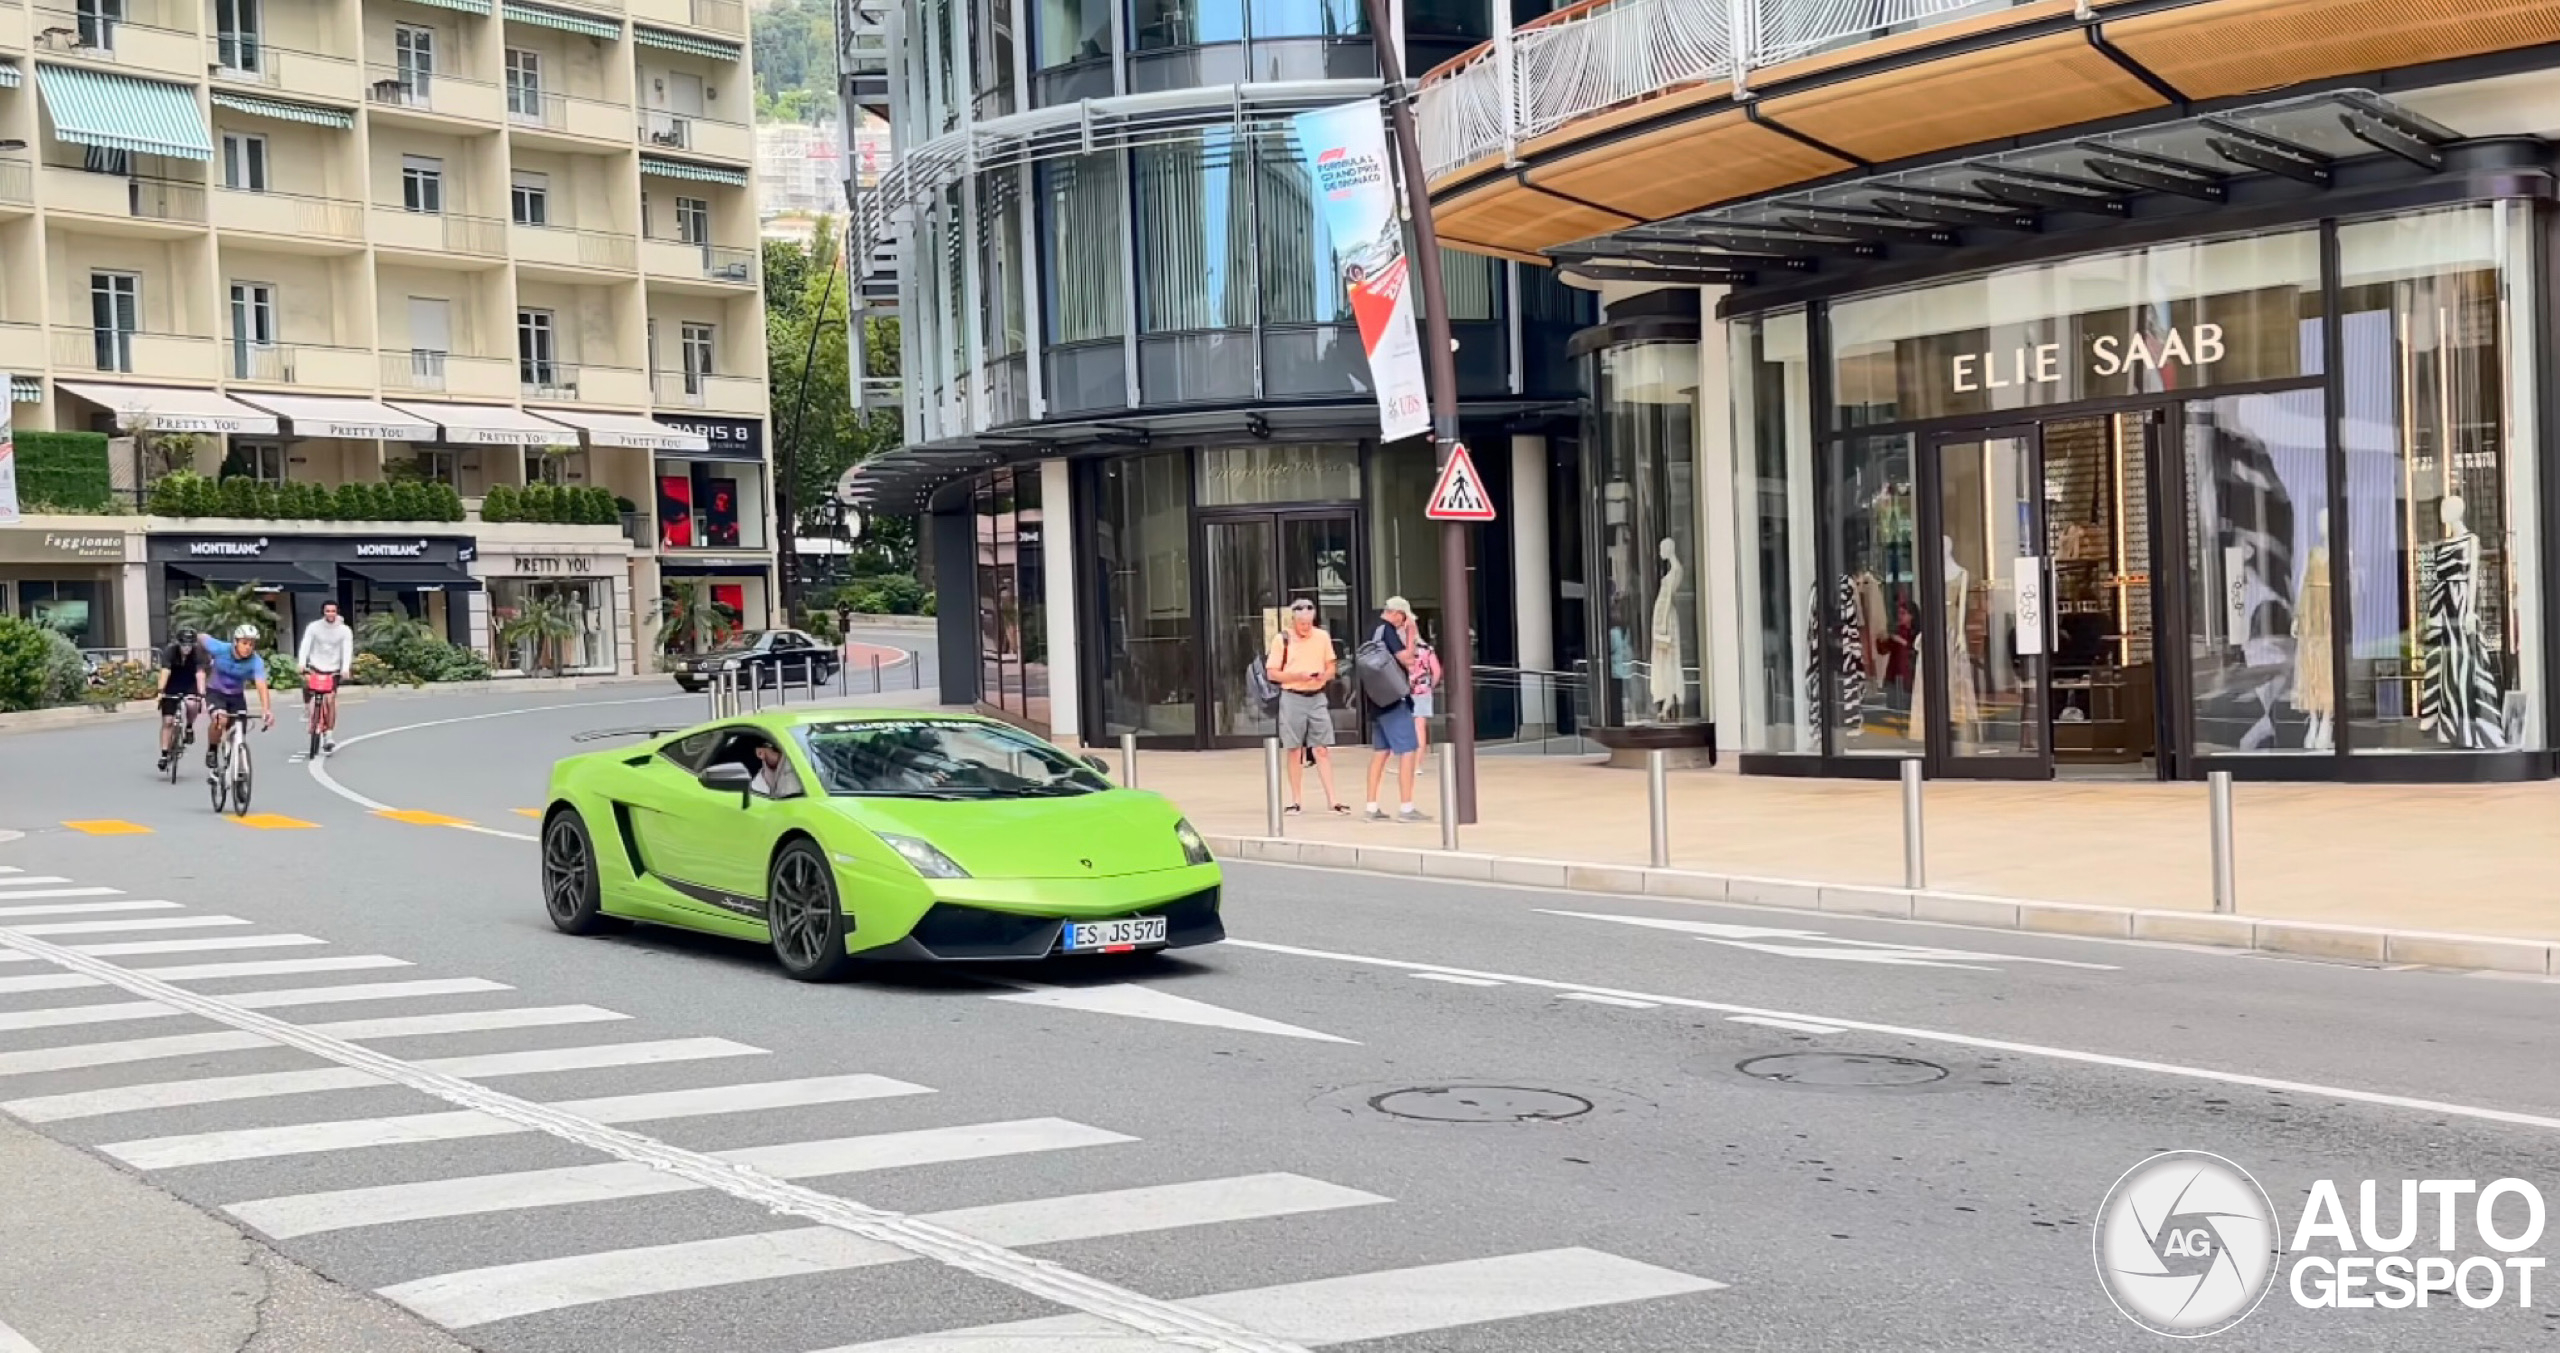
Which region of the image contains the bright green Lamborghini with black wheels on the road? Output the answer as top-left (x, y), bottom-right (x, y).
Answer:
top-left (540, 708), bottom-right (1226, 982)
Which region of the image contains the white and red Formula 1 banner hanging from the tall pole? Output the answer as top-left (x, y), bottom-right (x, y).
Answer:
top-left (1295, 102), bottom-right (1431, 442)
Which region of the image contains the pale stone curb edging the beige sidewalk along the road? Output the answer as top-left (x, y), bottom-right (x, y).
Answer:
top-left (1208, 836), bottom-right (2560, 977)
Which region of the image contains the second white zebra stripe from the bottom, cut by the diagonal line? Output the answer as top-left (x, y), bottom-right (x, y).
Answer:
top-left (381, 1174), bottom-right (1388, 1348)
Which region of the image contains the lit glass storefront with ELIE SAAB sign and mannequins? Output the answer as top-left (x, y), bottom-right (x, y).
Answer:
top-left (1740, 202), bottom-right (2545, 778)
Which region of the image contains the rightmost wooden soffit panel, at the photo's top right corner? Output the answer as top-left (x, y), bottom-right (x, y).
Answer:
top-left (2107, 0), bottom-right (2560, 100)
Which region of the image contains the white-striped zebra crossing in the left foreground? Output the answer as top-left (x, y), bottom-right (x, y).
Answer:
top-left (0, 867), bottom-right (1720, 1353)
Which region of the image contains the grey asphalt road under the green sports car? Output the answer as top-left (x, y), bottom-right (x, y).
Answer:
top-left (0, 647), bottom-right (2560, 1353)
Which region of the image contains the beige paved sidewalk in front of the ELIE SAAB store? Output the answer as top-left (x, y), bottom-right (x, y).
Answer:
top-left (1131, 747), bottom-right (2560, 939)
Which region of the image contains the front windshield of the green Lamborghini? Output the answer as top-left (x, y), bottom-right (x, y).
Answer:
top-left (799, 719), bottom-right (1111, 798)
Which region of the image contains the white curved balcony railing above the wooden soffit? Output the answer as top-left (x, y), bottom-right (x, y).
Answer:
top-left (1416, 0), bottom-right (2025, 176)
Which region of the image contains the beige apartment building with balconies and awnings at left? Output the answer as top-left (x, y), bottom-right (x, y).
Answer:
top-left (0, 0), bottom-right (776, 670)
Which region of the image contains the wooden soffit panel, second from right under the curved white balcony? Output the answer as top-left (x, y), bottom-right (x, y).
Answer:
top-left (1766, 31), bottom-right (2160, 161)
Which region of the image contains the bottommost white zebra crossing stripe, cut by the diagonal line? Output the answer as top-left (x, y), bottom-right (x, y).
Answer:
top-left (827, 1248), bottom-right (1725, 1353)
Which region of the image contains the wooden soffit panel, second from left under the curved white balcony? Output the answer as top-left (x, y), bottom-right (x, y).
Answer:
top-left (1526, 110), bottom-right (1856, 220)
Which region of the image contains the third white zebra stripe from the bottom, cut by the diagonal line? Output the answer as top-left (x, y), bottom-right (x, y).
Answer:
top-left (225, 1118), bottom-right (1137, 1240)
